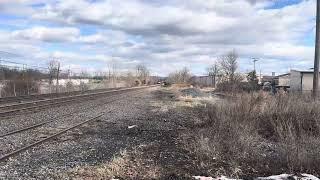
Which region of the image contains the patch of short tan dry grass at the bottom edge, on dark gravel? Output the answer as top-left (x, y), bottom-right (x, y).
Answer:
top-left (57, 149), bottom-right (161, 180)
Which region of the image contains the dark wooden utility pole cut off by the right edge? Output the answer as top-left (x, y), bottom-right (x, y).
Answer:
top-left (312, 0), bottom-right (320, 99)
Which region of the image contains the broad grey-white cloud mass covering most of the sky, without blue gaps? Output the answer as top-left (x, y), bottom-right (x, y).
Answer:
top-left (0, 0), bottom-right (315, 74)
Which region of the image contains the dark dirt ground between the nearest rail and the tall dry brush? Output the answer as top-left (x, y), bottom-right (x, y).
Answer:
top-left (0, 87), bottom-right (212, 179)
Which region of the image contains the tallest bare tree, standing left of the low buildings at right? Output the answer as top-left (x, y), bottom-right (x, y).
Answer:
top-left (219, 50), bottom-right (238, 82)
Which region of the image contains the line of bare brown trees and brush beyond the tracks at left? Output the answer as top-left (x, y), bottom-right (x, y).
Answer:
top-left (0, 60), bottom-right (159, 97)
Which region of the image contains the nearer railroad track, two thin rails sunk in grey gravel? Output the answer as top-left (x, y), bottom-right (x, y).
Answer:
top-left (0, 88), bottom-right (151, 162)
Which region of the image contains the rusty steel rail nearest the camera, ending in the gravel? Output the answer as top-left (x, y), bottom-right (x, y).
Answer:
top-left (0, 114), bottom-right (103, 162)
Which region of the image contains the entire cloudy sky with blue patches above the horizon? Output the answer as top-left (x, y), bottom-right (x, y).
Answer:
top-left (0, 0), bottom-right (316, 75)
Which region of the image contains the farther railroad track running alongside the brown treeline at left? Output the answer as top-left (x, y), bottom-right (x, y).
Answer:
top-left (0, 86), bottom-right (153, 118)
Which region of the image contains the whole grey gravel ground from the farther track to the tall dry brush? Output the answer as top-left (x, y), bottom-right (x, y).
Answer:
top-left (0, 87), bottom-right (316, 179)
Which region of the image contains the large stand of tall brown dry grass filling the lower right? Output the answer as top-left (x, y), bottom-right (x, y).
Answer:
top-left (187, 93), bottom-right (320, 177)
